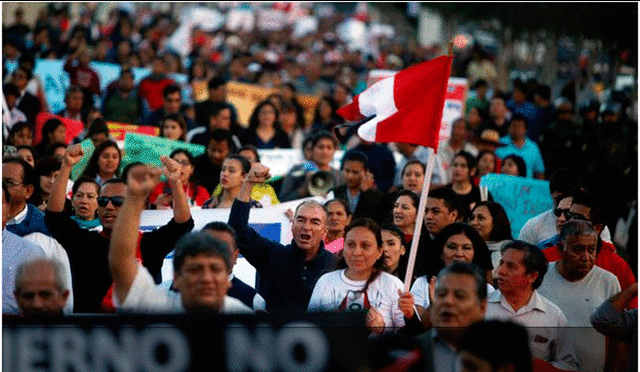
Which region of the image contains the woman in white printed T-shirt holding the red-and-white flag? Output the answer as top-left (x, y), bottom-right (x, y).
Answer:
top-left (308, 218), bottom-right (404, 334)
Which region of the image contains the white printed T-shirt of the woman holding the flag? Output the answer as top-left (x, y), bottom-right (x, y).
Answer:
top-left (307, 269), bottom-right (404, 331)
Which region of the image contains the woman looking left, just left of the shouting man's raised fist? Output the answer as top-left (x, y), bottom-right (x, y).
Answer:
top-left (202, 154), bottom-right (262, 208)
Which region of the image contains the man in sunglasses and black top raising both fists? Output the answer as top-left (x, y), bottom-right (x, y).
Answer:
top-left (45, 145), bottom-right (194, 313)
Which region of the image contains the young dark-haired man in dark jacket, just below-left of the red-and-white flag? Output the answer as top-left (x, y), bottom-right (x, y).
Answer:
top-left (329, 150), bottom-right (384, 223)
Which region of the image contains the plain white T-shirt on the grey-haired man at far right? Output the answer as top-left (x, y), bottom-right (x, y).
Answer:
top-left (538, 262), bottom-right (620, 372)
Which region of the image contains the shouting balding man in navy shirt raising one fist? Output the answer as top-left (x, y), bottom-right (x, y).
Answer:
top-left (229, 163), bottom-right (336, 313)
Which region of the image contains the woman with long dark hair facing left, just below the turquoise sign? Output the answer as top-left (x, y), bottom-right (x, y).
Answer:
top-left (469, 201), bottom-right (513, 276)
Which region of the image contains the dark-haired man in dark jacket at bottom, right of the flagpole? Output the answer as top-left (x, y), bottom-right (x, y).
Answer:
top-left (417, 262), bottom-right (487, 372)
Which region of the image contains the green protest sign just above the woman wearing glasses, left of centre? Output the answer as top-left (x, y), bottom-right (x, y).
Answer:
top-left (121, 133), bottom-right (205, 167)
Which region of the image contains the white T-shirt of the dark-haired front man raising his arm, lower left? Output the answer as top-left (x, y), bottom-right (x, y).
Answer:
top-left (113, 265), bottom-right (254, 314)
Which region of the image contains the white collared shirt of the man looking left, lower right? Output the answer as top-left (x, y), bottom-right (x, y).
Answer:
top-left (485, 290), bottom-right (578, 371)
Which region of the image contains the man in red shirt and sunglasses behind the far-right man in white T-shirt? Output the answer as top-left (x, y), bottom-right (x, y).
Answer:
top-left (542, 192), bottom-right (638, 308)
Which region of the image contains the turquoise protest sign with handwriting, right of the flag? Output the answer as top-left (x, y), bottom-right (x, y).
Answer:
top-left (480, 174), bottom-right (553, 236)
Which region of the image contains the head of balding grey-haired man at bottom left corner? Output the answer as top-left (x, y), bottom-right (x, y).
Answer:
top-left (13, 257), bottom-right (70, 316)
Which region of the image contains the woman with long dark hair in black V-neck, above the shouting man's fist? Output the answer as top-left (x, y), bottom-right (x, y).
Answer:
top-left (240, 100), bottom-right (291, 149)
